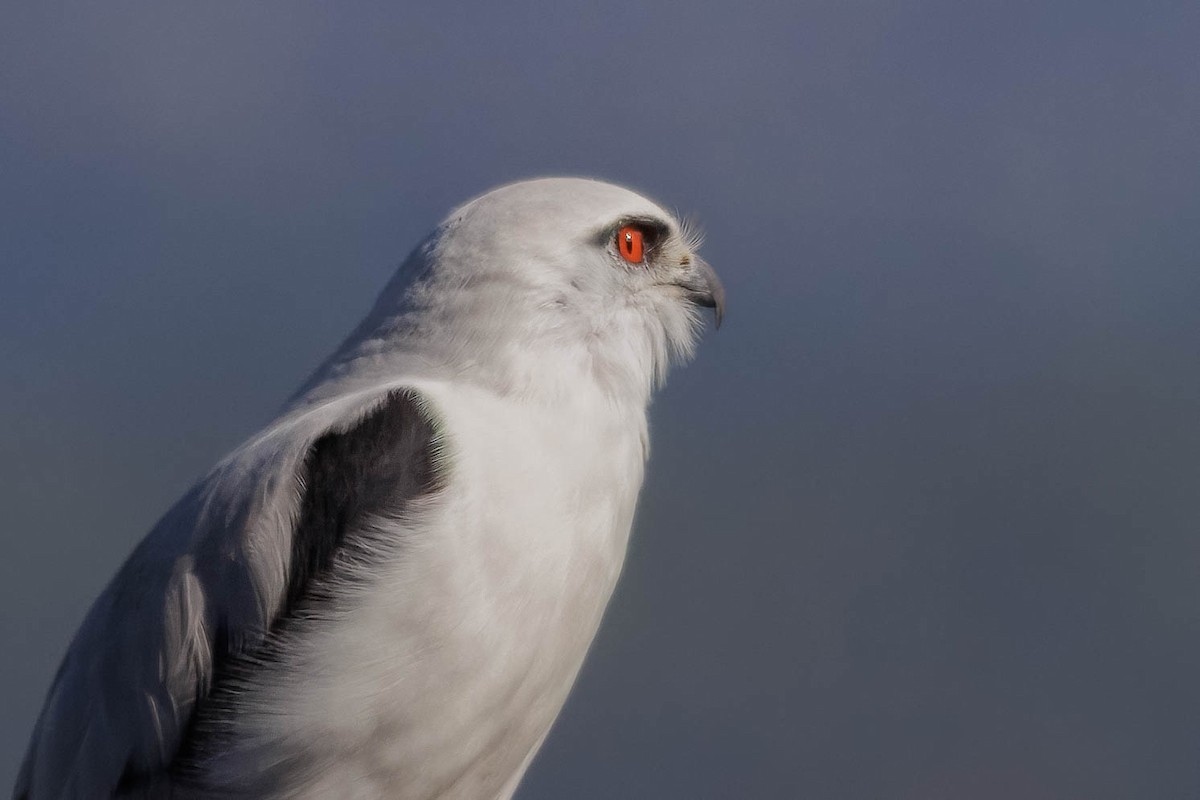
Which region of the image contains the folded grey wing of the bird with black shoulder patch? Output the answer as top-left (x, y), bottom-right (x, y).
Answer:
top-left (13, 387), bottom-right (443, 800)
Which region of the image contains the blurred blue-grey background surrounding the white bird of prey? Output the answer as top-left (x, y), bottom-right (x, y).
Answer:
top-left (0, 0), bottom-right (1200, 800)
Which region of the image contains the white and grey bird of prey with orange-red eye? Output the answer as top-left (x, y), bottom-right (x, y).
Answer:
top-left (13, 178), bottom-right (725, 800)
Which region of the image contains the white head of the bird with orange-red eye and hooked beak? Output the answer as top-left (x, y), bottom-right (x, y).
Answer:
top-left (296, 178), bottom-right (725, 404)
